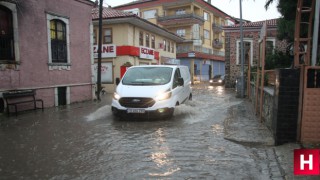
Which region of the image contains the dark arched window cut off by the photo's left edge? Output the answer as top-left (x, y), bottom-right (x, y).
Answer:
top-left (0, 5), bottom-right (15, 61)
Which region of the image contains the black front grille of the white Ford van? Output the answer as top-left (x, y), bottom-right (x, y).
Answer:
top-left (119, 98), bottom-right (155, 108)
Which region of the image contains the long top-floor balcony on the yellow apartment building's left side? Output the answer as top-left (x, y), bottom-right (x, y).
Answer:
top-left (158, 13), bottom-right (205, 26)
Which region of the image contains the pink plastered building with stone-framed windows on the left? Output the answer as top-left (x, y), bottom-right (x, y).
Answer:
top-left (0, 0), bottom-right (94, 112)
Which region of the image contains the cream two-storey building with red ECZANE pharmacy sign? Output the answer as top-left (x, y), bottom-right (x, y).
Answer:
top-left (92, 8), bottom-right (183, 92)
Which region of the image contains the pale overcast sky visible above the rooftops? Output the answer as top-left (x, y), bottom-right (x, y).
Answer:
top-left (99, 0), bottom-right (280, 21)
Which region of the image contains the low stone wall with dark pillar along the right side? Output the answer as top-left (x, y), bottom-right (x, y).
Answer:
top-left (249, 69), bottom-right (300, 145)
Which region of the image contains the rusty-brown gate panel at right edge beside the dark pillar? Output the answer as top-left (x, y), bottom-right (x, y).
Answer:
top-left (300, 66), bottom-right (320, 143)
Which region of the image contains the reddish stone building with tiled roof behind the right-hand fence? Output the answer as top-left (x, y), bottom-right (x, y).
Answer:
top-left (224, 19), bottom-right (287, 88)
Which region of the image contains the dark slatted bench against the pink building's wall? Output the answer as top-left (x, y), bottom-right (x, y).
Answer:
top-left (2, 90), bottom-right (43, 116)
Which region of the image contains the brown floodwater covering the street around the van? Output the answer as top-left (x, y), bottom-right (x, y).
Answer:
top-left (0, 84), bottom-right (276, 180)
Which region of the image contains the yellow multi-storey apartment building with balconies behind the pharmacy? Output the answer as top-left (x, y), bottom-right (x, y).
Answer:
top-left (114, 0), bottom-right (232, 83)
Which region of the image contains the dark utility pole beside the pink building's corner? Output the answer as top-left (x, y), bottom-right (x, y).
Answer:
top-left (97, 0), bottom-right (103, 101)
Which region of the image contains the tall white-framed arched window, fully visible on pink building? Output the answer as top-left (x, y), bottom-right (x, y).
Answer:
top-left (47, 14), bottom-right (71, 70)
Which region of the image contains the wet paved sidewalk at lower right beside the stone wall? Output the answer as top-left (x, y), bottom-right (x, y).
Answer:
top-left (224, 99), bottom-right (319, 180)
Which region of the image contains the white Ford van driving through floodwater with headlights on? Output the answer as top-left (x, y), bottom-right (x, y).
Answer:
top-left (111, 65), bottom-right (192, 117)
